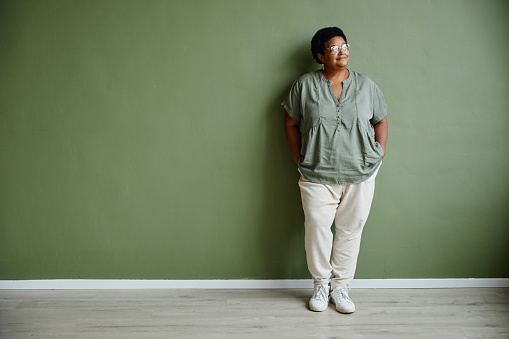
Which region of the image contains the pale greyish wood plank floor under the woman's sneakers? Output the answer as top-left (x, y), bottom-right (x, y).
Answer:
top-left (0, 288), bottom-right (509, 339)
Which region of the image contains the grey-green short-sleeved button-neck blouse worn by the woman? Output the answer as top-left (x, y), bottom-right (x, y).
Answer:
top-left (281, 70), bottom-right (387, 185)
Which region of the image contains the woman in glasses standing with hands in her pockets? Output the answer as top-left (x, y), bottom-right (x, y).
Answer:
top-left (282, 27), bottom-right (388, 313)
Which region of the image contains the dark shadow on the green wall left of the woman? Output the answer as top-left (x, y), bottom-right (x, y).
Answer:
top-left (254, 42), bottom-right (319, 287)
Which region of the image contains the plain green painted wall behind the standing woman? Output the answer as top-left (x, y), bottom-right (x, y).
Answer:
top-left (0, 0), bottom-right (509, 279)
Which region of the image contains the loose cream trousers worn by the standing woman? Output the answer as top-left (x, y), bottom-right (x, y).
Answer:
top-left (299, 169), bottom-right (378, 288)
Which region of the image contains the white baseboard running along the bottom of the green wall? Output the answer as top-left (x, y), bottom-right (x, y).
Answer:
top-left (0, 278), bottom-right (509, 290)
